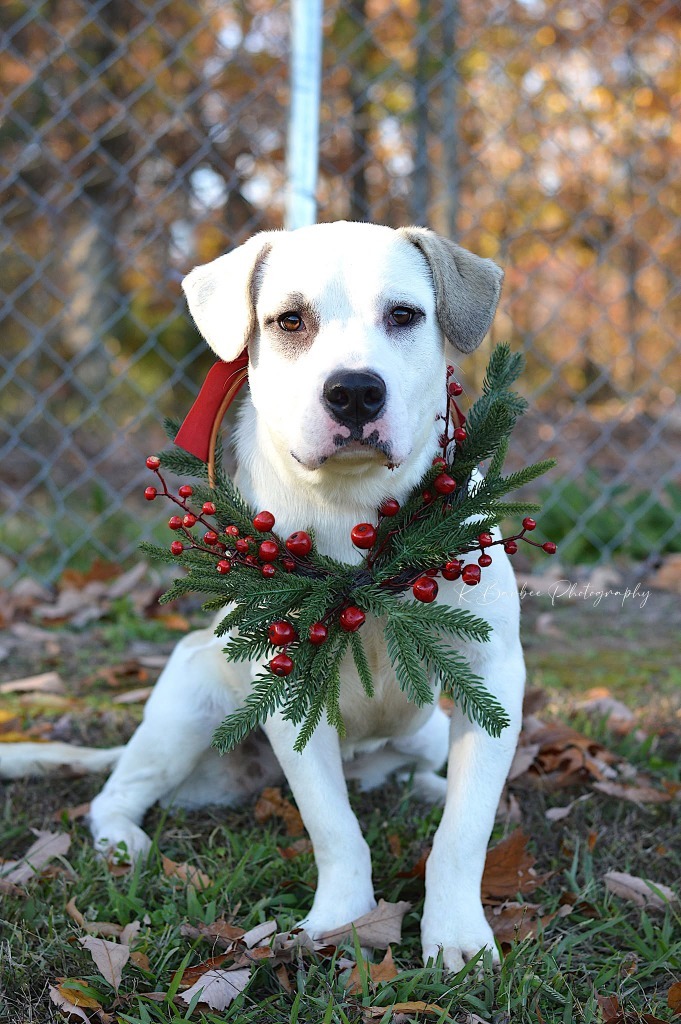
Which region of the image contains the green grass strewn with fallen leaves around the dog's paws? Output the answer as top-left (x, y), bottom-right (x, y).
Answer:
top-left (0, 589), bottom-right (681, 1024)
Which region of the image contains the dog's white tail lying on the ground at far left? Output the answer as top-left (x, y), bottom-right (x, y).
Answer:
top-left (0, 743), bottom-right (125, 779)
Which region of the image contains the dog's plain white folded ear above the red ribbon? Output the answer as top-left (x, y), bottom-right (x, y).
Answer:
top-left (182, 231), bottom-right (281, 362)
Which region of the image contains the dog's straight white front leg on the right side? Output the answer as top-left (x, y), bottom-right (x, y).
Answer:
top-left (421, 640), bottom-right (525, 971)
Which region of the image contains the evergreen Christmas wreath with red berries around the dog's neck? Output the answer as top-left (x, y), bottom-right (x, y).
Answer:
top-left (143, 345), bottom-right (556, 752)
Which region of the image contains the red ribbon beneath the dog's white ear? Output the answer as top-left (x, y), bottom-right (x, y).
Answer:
top-left (175, 350), bottom-right (248, 462)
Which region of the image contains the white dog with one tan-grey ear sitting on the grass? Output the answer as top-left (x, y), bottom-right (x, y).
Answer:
top-left (9, 222), bottom-right (524, 971)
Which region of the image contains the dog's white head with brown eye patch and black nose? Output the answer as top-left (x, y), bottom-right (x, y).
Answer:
top-left (182, 221), bottom-right (503, 473)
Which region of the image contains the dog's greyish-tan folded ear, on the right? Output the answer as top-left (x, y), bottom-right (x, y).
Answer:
top-left (399, 227), bottom-right (504, 352)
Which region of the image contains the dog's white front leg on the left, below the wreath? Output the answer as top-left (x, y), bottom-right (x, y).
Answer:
top-left (264, 713), bottom-right (376, 937)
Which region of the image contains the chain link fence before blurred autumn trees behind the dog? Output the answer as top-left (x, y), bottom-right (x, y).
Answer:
top-left (0, 0), bottom-right (681, 582)
